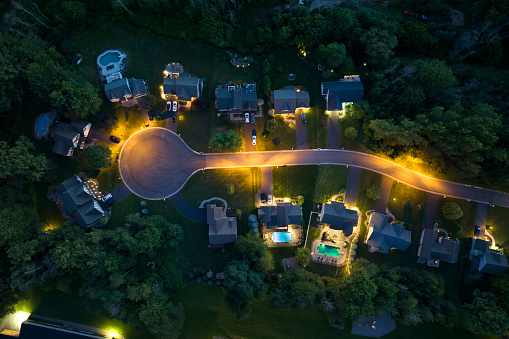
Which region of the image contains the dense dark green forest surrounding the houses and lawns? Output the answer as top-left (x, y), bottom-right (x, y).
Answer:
top-left (0, 0), bottom-right (509, 338)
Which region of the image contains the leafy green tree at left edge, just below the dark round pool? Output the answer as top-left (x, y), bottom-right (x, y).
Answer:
top-left (0, 136), bottom-right (48, 181)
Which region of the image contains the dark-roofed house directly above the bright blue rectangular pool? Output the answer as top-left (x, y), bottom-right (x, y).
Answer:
top-left (258, 202), bottom-right (302, 230)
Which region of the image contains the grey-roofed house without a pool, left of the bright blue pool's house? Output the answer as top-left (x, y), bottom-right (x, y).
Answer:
top-left (207, 205), bottom-right (237, 245)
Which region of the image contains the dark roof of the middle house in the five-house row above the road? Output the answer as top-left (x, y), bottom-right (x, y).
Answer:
top-left (216, 88), bottom-right (258, 113)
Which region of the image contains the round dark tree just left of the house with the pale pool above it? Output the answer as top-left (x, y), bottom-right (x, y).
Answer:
top-left (50, 79), bottom-right (102, 120)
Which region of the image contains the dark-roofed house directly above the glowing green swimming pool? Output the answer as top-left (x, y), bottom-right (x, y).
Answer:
top-left (320, 201), bottom-right (359, 236)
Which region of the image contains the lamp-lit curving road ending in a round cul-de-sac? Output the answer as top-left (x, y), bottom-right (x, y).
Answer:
top-left (119, 128), bottom-right (509, 207)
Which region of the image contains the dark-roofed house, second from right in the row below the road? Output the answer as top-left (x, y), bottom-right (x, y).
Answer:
top-left (417, 226), bottom-right (460, 267)
